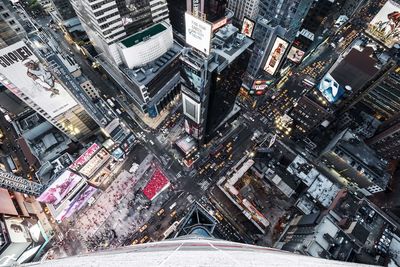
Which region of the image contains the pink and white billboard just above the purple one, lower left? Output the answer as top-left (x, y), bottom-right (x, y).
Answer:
top-left (37, 170), bottom-right (84, 205)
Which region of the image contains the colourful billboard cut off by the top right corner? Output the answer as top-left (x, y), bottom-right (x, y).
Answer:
top-left (366, 0), bottom-right (400, 48)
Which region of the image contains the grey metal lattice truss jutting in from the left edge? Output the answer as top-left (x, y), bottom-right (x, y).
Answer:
top-left (0, 170), bottom-right (43, 196)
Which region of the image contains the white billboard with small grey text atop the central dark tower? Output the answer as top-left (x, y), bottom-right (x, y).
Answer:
top-left (185, 13), bottom-right (212, 55)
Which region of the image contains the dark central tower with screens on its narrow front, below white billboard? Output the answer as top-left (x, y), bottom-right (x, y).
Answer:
top-left (181, 23), bottom-right (253, 144)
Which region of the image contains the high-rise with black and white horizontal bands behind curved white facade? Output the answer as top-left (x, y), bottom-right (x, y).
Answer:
top-left (71, 0), bottom-right (169, 64)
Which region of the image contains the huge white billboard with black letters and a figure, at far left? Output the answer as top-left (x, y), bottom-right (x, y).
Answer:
top-left (0, 41), bottom-right (77, 118)
